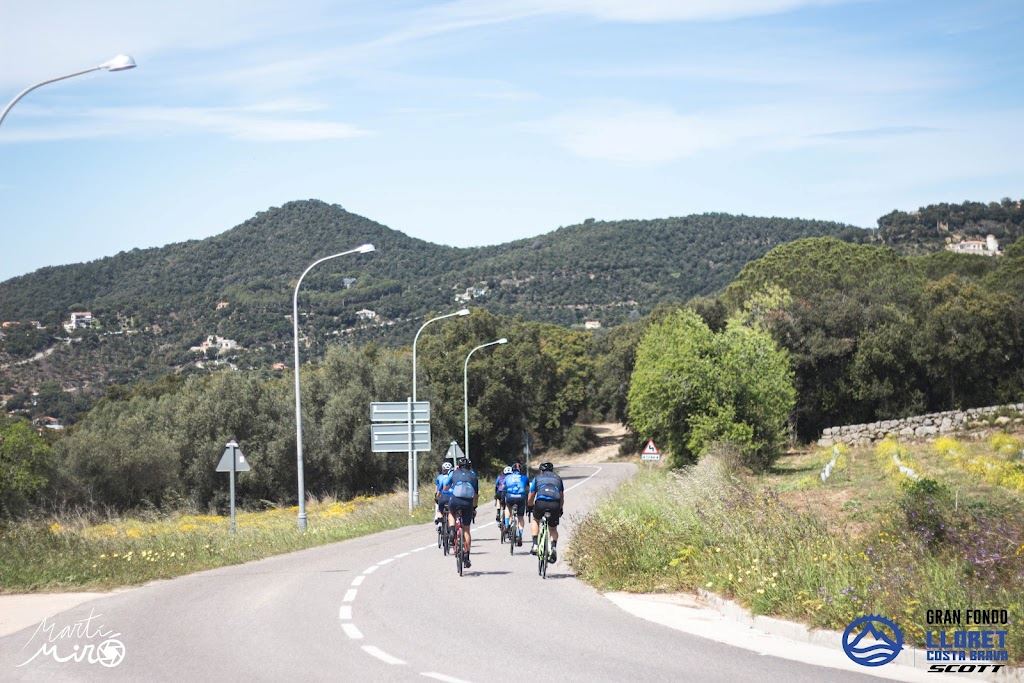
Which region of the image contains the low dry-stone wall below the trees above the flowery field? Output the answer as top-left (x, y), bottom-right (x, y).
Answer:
top-left (818, 403), bottom-right (1024, 445)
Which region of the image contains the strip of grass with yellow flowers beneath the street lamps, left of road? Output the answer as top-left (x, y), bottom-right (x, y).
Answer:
top-left (0, 490), bottom-right (433, 593)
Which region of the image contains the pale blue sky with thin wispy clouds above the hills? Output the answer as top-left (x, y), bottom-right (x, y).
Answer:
top-left (0, 0), bottom-right (1024, 280)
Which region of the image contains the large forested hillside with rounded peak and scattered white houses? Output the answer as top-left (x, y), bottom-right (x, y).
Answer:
top-left (0, 201), bottom-right (860, 411)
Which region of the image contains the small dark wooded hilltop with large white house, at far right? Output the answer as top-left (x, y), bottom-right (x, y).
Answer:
top-left (878, 198), bottom-right (1024, 253)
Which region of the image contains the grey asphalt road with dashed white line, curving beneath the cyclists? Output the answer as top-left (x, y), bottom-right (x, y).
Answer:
top-left (0, 463), bottom-right (866, 683)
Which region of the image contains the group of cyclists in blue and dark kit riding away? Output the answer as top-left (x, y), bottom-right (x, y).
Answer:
top-left (434, 458), bottom-right (565, 567)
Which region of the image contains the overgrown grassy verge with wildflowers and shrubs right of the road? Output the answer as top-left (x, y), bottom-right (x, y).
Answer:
top-left (568, 444), bottom-right (1024, 660)
